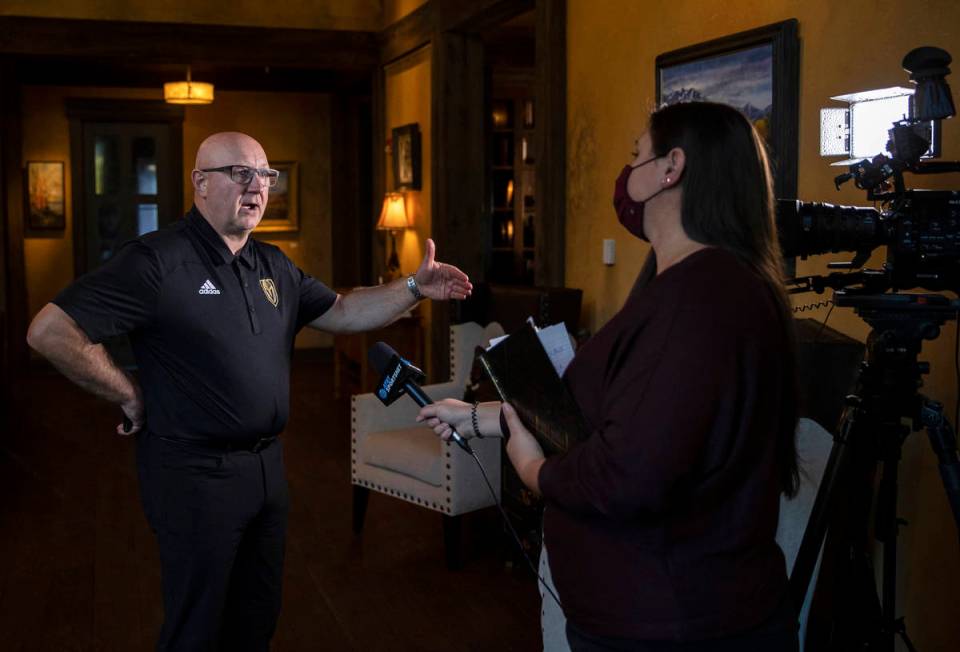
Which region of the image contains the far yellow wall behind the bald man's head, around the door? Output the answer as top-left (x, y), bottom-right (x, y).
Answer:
top-left (23, 86), bottom-right (333, 347)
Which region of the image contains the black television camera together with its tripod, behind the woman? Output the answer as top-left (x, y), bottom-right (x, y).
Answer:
top-left (777, 47), bottom-right (960, 652)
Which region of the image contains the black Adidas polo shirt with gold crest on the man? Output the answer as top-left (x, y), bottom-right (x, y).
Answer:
top-left (53, 206), bottom-right (337, 440)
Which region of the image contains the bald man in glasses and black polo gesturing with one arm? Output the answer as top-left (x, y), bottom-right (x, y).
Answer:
top-left (27, 132), bottom-right (471, 651)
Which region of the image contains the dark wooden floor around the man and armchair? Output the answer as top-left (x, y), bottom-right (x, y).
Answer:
top-left (0, 353), bottom-right (540, 652)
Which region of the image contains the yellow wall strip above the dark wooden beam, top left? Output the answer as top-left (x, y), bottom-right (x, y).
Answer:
top-left (0, 0), bottom-right (382, 31)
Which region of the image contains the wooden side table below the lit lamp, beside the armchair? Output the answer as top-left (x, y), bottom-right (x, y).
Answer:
top-left (333, 308), bottom-right (423, 398)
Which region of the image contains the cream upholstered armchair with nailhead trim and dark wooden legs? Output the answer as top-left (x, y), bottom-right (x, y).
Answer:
top-left (350, 322), bottom-right (503, 568)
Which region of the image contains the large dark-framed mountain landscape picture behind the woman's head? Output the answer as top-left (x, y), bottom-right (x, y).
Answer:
top-left (655, 18), bottom-right (800, 198)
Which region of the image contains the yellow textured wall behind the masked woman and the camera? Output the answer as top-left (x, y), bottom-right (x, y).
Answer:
top-left (566, 0), bottom-right (960, 651)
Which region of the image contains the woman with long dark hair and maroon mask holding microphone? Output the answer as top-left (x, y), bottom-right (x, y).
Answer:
top-left (420, 102), bottom-right (798, 652)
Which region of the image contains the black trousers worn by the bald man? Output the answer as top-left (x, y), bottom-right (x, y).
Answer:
top-left (137, 433), bottom-right (289, 652)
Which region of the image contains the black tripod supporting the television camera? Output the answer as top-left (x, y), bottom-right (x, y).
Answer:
top-left (790, 292), bottom-right (960, 652)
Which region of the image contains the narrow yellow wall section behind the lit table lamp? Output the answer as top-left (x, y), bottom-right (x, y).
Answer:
top-left (382, 46), bottom-right (432, 369)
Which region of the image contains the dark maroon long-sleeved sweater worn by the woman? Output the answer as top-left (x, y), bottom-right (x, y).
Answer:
top-left (539, 248), bottom-right (790, 640)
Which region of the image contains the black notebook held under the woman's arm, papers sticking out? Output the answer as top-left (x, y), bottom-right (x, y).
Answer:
top-left (480, 323), bottom-right (589, 456)
